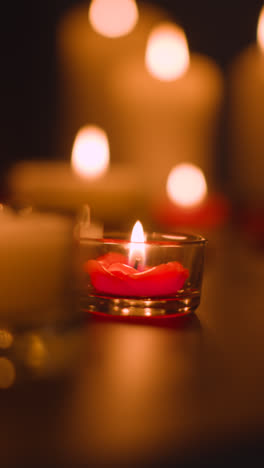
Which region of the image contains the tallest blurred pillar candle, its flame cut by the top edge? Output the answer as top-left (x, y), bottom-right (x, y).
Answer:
top-left (57, 0), bottom-right (167, 157)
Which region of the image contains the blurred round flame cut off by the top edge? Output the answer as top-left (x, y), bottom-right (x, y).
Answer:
top-left (89, 0), bottom-right (138, 37)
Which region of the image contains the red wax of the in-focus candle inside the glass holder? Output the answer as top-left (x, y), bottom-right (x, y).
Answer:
top-left (84, 252), bottom-right (189, 297)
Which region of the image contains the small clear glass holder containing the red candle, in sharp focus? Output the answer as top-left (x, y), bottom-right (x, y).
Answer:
top-left (80, 233), bottom-right (207, 317)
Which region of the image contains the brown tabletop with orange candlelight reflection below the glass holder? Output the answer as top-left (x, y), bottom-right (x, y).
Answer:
top-left (0, 229), bottom-right (264, 467)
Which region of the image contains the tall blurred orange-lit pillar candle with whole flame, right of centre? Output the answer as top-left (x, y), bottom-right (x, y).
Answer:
top-left (105, 23), bottom-right (223, 195)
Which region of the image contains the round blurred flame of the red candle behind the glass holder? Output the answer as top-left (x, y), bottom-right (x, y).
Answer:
top-left (167, 164), bottom-right (207, 208)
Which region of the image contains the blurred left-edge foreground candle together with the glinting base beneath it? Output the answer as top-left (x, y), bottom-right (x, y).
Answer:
top-left (0, 209), bottom-right (85, 382)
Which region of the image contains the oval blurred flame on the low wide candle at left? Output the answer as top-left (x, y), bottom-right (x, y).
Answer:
top-left (71, 126), bottom-right (109, 178)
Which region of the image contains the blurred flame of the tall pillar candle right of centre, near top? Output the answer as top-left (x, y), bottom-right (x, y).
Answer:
top-left (145, 22), bottom-right (190, 81)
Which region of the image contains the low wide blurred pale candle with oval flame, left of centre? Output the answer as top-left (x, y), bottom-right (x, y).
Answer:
top-left (8, 126), bottom-right (144, 225)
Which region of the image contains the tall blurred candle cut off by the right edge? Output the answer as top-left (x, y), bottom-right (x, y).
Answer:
top-left (229, 7), bottom-right (264, 203)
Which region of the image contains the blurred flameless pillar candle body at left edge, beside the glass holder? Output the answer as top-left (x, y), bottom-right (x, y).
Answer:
top-left (0, 214), bottom-right (76, 327)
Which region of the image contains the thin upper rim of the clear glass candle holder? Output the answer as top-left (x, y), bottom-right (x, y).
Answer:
top-left (80, 231), bottom-right (208, 247)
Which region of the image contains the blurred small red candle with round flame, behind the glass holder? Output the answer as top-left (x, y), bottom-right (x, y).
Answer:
top-left (153, 164), bottom-right (230, 233)
